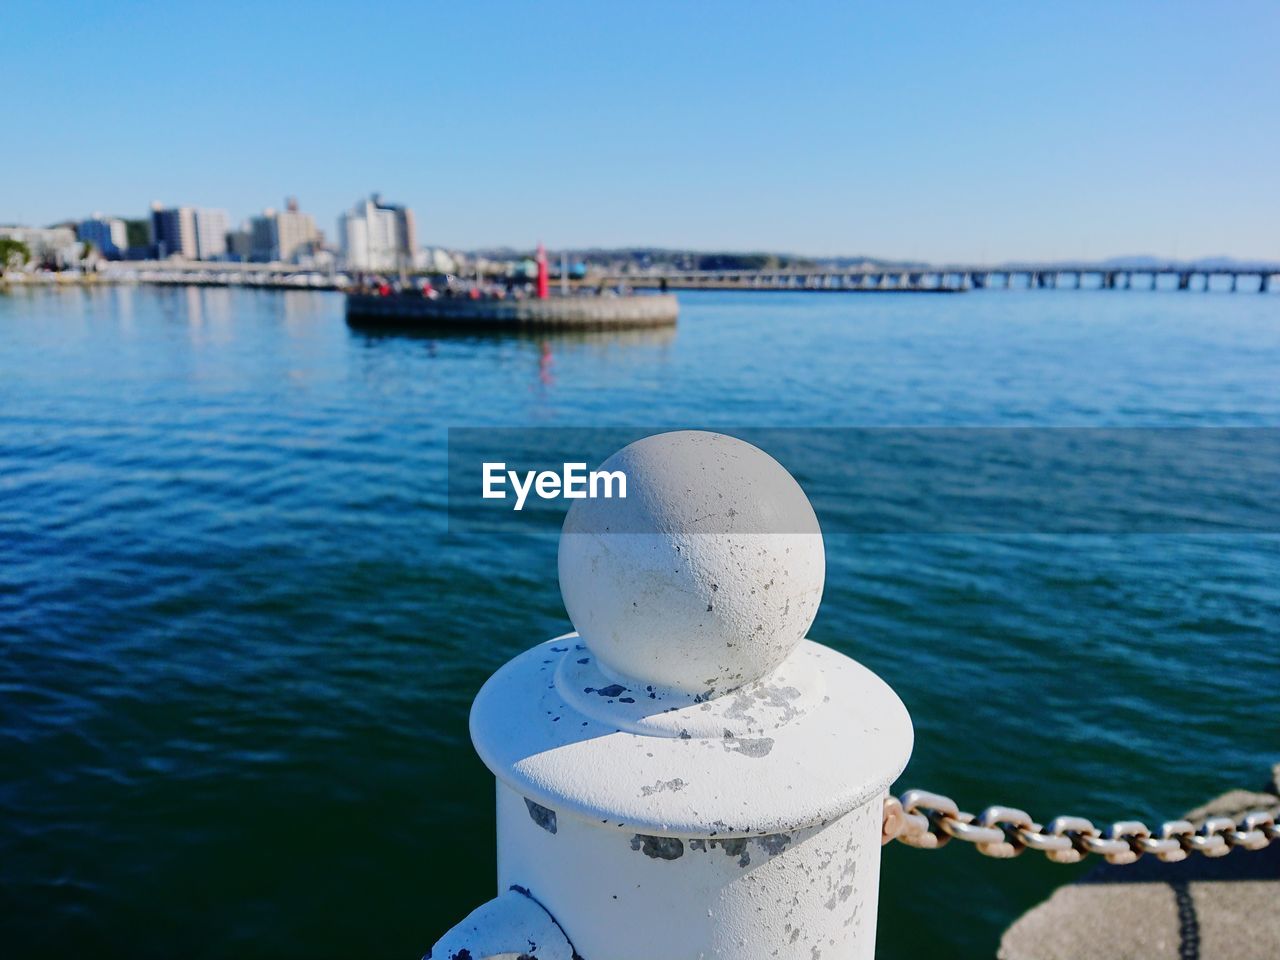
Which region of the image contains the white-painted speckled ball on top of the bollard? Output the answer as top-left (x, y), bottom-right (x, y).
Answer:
top-left (559, 430), bottom-right (826, 699)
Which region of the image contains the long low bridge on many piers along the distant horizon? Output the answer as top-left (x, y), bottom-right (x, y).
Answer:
top-left (607, 264), bottom-right (1280, 293)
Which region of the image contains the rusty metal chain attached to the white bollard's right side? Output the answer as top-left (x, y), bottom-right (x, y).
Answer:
top-left (881, 790), bottom-right (1280, 864)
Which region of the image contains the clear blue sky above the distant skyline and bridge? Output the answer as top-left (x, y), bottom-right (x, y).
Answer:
top-left (0, 0), bottom-right (1280, 261)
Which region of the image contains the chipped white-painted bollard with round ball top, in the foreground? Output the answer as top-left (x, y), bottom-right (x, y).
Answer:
top-left (428, 431), bottom-right (913, 960)
